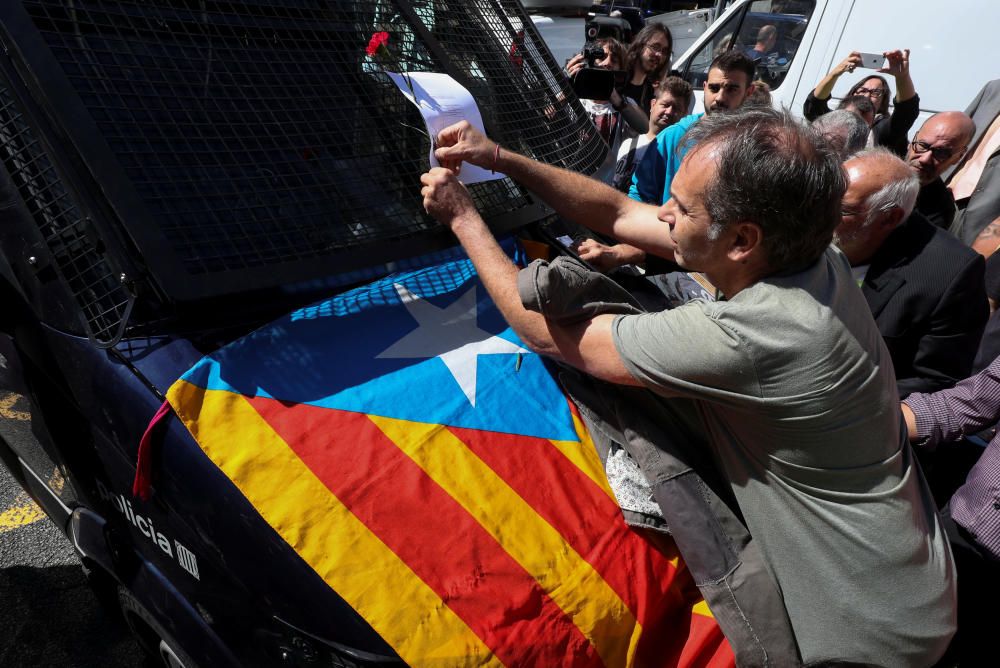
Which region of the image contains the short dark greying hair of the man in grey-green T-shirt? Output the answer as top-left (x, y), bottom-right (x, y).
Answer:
top-left (682, 107), bottom-right (847, 271)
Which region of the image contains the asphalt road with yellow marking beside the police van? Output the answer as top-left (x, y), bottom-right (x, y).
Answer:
top-left (0, 390), bottom-right (150, 668)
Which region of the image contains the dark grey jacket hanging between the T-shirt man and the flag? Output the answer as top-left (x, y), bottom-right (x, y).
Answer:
top-left (518, 257), bottom-right (801, 667)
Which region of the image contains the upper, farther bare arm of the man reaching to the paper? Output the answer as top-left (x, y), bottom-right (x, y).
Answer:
top-left (434, 121), bottom-right (673, 259)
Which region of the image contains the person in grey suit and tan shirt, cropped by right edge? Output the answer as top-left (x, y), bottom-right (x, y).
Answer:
top-left (946, 79), bottom-right (1000, 245)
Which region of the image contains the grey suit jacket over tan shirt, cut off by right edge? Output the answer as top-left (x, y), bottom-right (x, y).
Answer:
top-left (946, 79), bottom-right (1000, 245)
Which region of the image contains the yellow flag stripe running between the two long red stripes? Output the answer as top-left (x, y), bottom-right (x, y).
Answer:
top-left (369, 415), bottom-right (642, 666)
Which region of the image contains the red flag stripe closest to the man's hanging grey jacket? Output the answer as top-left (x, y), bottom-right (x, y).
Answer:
top-left (449, 427), bottom-right (732, 666)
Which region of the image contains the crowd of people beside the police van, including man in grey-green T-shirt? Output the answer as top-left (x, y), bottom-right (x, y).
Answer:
top-left (422, 25), bottom-right (1000, 666)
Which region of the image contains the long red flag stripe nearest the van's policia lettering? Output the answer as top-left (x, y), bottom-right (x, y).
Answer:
top-left (248, 397), bottom-right (602, 666)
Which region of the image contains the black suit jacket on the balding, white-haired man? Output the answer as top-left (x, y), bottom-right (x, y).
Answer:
top-left (861, 213), bottom-right (989, 397)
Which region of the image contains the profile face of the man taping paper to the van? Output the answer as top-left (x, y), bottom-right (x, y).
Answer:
top-left (657, 147), bottom-right (725, 273)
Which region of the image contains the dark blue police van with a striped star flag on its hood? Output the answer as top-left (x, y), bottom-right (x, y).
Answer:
top-left (0, 0), bottom-right (752, 668)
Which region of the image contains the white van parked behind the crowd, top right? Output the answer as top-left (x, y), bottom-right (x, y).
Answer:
top-left (673, 0), bottom-right (1000, 130)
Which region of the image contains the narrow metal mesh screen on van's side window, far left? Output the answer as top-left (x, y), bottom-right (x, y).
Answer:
top-left (0, 85), bottom-right (132, 345)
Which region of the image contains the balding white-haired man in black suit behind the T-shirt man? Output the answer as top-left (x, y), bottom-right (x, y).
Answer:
top-left (834, 148), bottom-right (989, 397)
